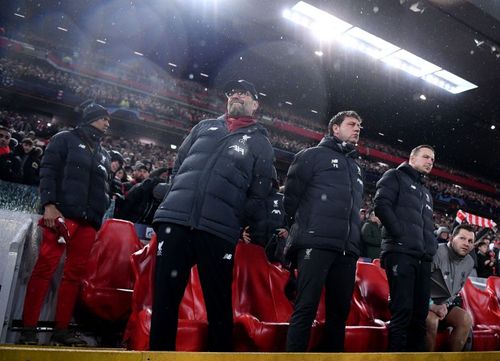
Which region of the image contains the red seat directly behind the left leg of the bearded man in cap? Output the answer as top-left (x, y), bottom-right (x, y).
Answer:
top-left (124, 236), bottom-right (208, 351)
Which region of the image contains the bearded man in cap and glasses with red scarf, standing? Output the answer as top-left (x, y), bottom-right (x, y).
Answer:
top-left (150, 80), bottom-right (274, 351)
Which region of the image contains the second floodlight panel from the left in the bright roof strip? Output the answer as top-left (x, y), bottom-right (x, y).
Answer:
top-left (341, 27), bottom-right (399, 59)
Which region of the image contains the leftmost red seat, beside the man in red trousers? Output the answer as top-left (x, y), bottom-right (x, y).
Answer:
top-left (81, 219), bottom-right (142, 321)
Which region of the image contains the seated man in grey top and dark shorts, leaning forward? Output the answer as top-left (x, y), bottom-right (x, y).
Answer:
top-left (426, 224), bottom-right (474, 352)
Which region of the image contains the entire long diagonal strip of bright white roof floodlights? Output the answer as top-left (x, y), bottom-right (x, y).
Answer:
top-left (283, 1), bottom-right (477, 94)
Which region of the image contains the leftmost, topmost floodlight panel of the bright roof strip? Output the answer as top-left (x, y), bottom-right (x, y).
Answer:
top-left (283, 1), bottom-right (352, 40)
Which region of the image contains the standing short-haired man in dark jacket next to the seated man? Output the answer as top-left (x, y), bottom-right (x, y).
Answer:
top-left (374, 145), bottom-right (437, 352)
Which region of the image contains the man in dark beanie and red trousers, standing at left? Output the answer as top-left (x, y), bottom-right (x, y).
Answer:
top-left (20, 101), bottom-right (111, 346)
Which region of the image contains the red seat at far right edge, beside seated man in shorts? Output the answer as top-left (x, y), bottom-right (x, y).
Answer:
top-left (461, 279), bottom-right (500, 351)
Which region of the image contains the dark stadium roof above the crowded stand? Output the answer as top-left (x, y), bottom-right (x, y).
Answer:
top-left (0, 0), bottom-right (500, 182)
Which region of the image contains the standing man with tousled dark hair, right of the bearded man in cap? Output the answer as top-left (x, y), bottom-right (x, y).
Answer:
top-left (284, 111), bottom-right (363, 352)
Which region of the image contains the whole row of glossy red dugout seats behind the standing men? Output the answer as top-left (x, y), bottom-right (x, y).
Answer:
top-left (81, 219), bottom-right (500, 352)
